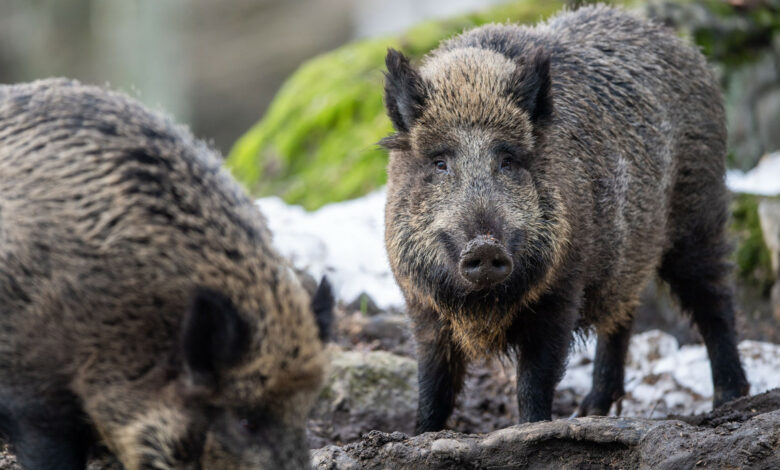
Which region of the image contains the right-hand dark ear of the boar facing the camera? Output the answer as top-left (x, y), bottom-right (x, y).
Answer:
top-left (509, 49), bottom-right (552, 124)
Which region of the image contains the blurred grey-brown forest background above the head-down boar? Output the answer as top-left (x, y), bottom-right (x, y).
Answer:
top-left (0, 0), bottom-right (508, 153)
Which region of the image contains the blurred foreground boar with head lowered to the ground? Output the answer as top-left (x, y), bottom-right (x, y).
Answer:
top-left (0, 80), bottom-right (332, 470)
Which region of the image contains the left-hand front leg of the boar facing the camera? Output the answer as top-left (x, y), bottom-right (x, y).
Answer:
top-left (415, 316), bottom-right (466, 434)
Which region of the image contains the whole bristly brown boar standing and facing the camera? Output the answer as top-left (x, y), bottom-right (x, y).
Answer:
top-left (382, 6), bottom-right (749, 432)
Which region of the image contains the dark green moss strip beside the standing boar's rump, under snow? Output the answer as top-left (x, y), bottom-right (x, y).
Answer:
top-left (731, 194), bottom-right (774, 294)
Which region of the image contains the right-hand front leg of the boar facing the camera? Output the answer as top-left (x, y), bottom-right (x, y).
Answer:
top-left (510, 295), bottom-right (577, 423)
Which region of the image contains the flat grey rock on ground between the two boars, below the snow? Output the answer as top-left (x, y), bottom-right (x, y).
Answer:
top-left (309, 347), bottom-right (417, 445)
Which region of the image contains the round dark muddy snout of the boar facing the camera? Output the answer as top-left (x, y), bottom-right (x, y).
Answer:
top-left (459, 235), bottom-right (513, 289)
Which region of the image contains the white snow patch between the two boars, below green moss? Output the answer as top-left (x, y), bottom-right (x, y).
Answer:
top-left (257, 190), bottom-right (404, 309)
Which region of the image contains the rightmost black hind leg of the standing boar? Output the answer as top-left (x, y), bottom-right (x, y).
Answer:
top-left (660, 231), bottom-right (750, 408)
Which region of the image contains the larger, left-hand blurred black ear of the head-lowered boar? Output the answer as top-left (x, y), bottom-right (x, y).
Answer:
top-left (181, 288), bottom-right (250, 387)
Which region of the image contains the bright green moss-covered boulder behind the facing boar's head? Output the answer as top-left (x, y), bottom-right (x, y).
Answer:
top-left (227, 0), bottom-right (564, 209)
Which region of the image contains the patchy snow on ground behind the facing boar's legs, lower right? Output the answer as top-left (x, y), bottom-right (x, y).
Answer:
top-left (558, 330), bottom-right (780, 418)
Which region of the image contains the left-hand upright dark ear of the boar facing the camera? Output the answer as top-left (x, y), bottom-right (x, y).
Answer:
top-left (385, 49), bottom-right (425, 132)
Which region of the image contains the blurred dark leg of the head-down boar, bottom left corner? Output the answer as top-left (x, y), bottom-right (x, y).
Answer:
top-left (8, 398), bottom-right (92, 470)
